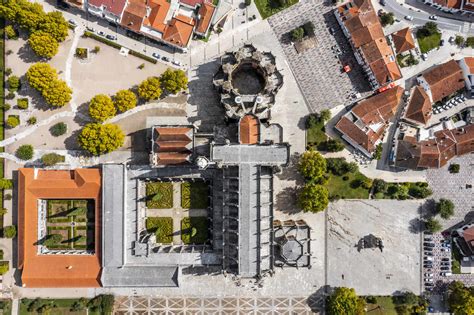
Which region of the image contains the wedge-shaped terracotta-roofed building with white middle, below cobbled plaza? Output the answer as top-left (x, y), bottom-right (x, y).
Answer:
top-left (335, 86), bottom-right (403, 156)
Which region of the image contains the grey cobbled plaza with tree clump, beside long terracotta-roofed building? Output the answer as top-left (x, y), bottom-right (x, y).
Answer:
top-left (268, 0), bottom-right (369, 112)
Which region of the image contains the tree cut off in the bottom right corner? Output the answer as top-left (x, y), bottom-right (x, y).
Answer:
top-left (448, 281), bottom-right (474, 315)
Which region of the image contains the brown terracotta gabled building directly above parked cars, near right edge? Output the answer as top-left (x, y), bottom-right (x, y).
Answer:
top-left (418, 59), bottom-right (464, 103)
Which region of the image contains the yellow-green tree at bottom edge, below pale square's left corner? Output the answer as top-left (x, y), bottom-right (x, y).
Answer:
top-left (326, 287), bottom-right (365, 315)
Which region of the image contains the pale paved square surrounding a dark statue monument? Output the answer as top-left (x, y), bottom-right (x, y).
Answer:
top-left (327, 200), bottom-right (421, 295)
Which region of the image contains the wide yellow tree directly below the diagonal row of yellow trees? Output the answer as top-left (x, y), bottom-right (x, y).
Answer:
top-left (78, 123), bottom-right (125, 155)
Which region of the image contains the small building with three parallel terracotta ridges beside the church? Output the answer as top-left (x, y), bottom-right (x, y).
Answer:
top-left (151, 126), bottom-right (194, 166)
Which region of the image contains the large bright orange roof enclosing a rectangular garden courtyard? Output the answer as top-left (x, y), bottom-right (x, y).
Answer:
top-left (18, 168), bottom-right (101, 288)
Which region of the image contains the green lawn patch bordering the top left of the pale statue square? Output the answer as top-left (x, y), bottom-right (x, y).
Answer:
top-left (326, 172), bottom-right (369, 199)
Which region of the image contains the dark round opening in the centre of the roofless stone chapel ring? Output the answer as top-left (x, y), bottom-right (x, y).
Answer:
top-left (232, 63), bottom-right (265, 95)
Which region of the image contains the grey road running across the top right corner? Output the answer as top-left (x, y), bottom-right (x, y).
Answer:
top-left (383, 0), bottom-right (474, 35)
